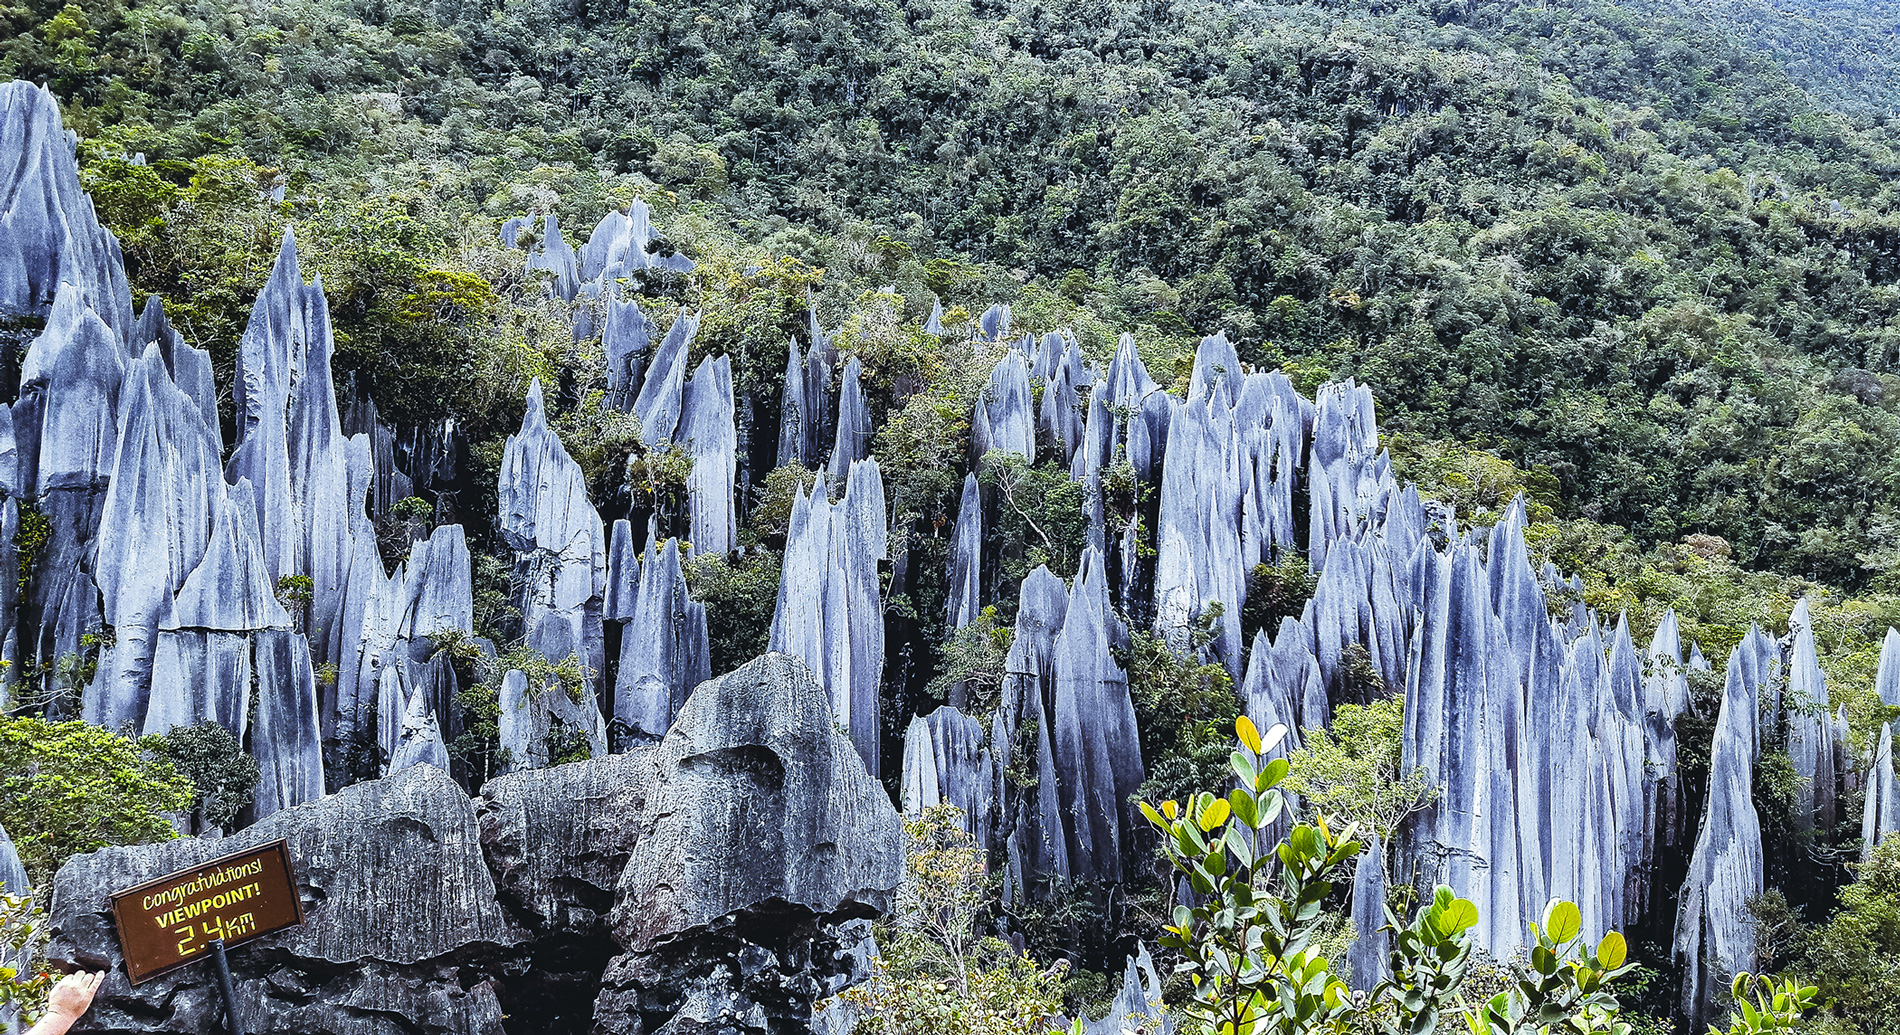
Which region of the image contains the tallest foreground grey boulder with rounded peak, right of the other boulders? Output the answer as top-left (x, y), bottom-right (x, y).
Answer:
top-left (595, 653), bottom-right (903, 1033)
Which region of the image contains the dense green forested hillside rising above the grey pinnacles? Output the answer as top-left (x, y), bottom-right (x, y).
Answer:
top-left (4, 0), bottom-right (1900, 587)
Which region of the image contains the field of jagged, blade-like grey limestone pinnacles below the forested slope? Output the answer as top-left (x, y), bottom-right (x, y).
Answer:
top-left (18, 76), bottom-right (1900, 1029)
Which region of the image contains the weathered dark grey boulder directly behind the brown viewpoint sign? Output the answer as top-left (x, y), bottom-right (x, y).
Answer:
top-left (49, 767), bottom-right (519, 1035)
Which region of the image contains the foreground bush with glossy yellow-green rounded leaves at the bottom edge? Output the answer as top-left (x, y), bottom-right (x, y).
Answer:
top-left (1142, 716), bottom-right (1816, 1035)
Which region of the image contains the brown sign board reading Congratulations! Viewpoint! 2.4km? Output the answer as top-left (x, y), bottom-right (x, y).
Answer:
top-left (112, 839), bottom-right (304, 984)
